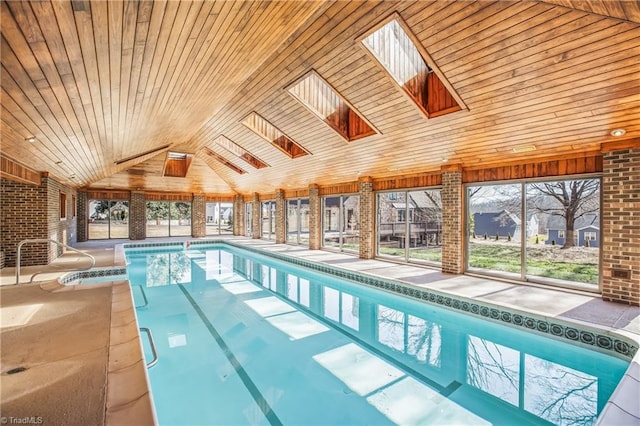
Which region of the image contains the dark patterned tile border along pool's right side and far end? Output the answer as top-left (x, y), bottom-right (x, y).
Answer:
top-left (125, 240), bottom-right (638, 360)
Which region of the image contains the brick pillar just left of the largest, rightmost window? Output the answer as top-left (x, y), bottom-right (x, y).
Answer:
top-left (442, 166), bottom-right (464, 274)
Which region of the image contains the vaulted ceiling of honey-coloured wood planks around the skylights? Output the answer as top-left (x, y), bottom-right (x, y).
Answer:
top-left (0, 0), bottom-right (640, 194)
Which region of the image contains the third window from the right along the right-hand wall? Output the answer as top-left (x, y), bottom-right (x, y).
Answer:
top-left (322, 195), bottom-right (360, 251)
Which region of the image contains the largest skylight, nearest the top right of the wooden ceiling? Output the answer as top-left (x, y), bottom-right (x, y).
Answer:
top-left (362, 16), bottom-right (462, 117)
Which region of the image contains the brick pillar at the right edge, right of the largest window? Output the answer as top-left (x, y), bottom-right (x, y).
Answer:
top-left (601, 149), bottom-right (640, 306)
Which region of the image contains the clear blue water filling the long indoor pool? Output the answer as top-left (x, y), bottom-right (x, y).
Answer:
top-left (126, 245), bottom-right (628, 425)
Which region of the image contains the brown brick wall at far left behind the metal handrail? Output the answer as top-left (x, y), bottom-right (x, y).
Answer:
top-left (0, 174), bottom-right (77, 266)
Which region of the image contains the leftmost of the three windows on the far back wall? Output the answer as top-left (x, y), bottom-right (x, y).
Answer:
top-left (88, 200), bottom-right (129, 240)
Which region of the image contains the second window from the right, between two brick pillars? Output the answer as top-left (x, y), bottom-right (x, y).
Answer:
top-left (377, 189), bottom-right (442, 263)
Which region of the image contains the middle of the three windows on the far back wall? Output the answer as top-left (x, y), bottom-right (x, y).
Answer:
top-left (147, 201), bottom-right (191, 237)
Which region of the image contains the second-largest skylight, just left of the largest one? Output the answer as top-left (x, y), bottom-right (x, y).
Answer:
top-left (288, 71), bottom-right (376, 142)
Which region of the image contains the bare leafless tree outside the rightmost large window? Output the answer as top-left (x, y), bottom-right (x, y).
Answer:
top-left (531, 179), bottom-right (600, 248)
